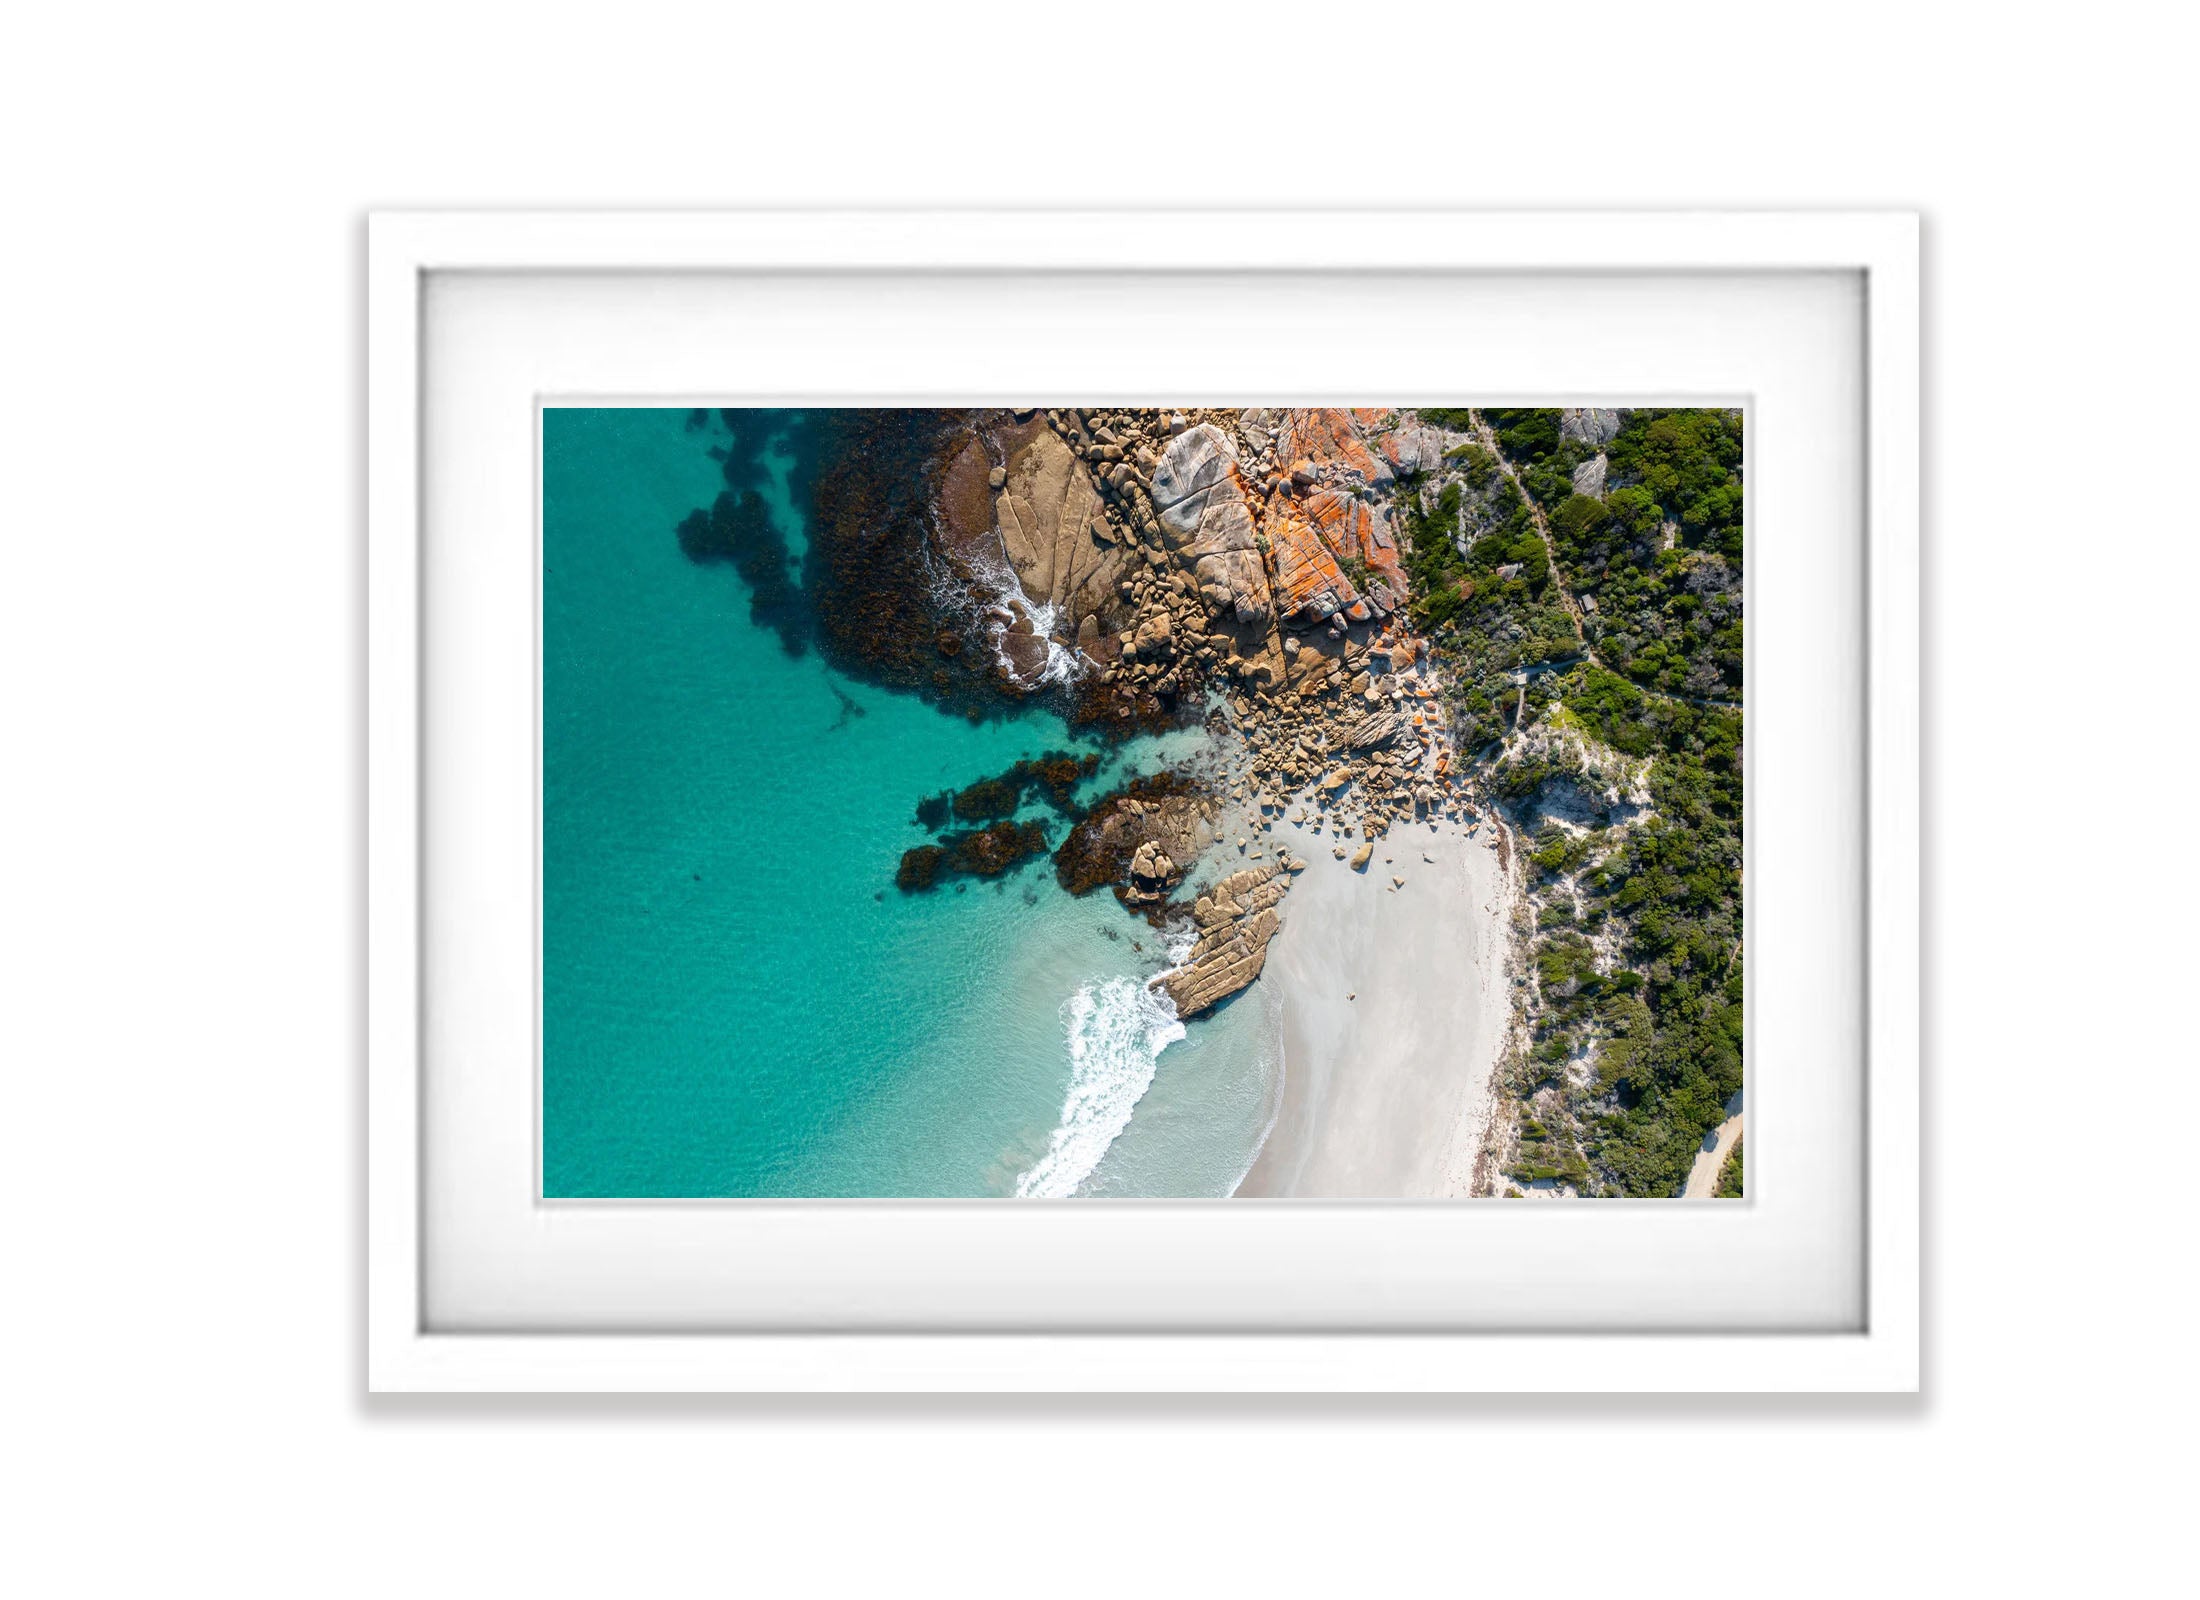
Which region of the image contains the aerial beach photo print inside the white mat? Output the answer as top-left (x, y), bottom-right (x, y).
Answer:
top-left (541, 403), bottom-right (1745, 1199)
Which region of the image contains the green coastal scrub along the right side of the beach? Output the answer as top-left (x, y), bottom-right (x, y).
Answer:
top-left (1401, 409), bottom-right (1742, 1195)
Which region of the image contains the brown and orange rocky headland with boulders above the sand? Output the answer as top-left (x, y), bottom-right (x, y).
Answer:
top-left (887, 407), bottom-right (1496, 1015)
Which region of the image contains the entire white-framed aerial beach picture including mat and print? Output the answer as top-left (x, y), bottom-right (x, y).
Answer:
top-left (367, 211), bottom-right (1918, 1391)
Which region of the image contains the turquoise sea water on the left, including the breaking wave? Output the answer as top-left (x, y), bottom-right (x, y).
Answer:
top-left (543, 409), bottom-right (1276, 1197)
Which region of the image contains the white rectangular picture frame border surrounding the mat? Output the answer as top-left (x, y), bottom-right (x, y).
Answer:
top-left (367, 211), bottom-right (1921, 1391)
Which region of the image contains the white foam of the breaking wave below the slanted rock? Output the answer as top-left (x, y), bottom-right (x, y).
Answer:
top-left (1016, 977), bottom-right (1184, 1199)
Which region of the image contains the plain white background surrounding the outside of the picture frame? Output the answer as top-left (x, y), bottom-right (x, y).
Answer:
top-left (0, 2), bottom-right (2196, 1596)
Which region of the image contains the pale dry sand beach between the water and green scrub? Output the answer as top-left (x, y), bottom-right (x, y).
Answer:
top-left (1225, 821), bottom-right (1511, 1197)
